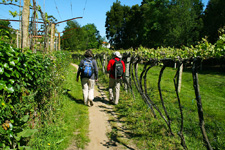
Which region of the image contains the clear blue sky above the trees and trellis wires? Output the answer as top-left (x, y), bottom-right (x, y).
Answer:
top-left (0, 0), bottom-right (209, 37)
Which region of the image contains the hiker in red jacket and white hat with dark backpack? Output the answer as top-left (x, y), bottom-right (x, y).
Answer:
top-left (107, 51), bottom-right (125, 105)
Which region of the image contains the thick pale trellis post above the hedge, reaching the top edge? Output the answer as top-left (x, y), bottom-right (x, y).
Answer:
top-left (22, 0), bottom-right (30, 51)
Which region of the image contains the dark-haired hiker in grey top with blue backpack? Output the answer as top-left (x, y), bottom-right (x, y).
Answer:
top-left (77, 50), bottom-right (98, 106)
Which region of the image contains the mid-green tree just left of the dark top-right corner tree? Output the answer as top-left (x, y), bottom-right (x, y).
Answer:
top-left (165, 0), bottom-right (203, 47)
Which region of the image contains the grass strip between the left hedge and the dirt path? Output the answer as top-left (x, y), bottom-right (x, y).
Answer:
top-left (29, 65), bottom-right (89, 150)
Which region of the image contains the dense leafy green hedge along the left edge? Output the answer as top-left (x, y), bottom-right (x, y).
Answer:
top-left (0, 41), bottom-right (52, 148)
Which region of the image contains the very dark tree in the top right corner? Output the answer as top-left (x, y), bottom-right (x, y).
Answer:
top-left (203, 0), bottom-right (225, 43)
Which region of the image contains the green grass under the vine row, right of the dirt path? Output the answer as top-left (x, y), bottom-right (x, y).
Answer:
top-left (100, 65), bottom-right (225, 150)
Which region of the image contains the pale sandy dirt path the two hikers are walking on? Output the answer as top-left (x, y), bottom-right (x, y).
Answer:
top-left (86, 84), bottom-right (116, 150)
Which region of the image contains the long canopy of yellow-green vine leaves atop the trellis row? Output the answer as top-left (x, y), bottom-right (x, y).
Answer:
top-left (81, 34), bottom-right (225, 60)
